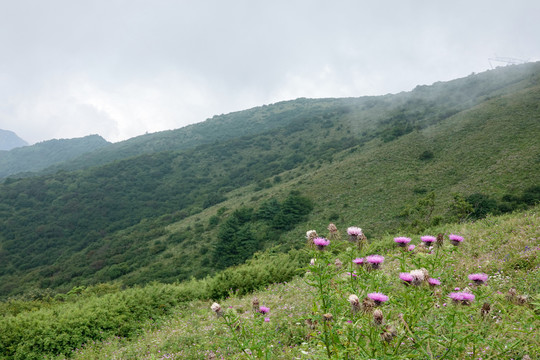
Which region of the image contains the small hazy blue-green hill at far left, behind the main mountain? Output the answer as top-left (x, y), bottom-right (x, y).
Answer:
top-left (0, 135), bottom-right (109, 179)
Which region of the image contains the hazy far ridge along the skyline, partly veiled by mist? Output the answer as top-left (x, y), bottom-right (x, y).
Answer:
top-left (35, 63), bottom-right (539, 173)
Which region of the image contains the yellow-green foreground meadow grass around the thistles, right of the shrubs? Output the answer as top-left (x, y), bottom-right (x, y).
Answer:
top-left (59, 206), bottom-right (540, 359)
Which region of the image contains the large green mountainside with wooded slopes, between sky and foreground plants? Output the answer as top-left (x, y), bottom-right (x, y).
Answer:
top-left (0, 63), bottom-right (540, 296)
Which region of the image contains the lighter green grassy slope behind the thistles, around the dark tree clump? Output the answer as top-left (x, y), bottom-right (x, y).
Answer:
top-left (112, 79), bottom-right (540, 286)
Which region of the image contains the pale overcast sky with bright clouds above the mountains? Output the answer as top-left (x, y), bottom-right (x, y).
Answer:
top-left (0, 0), bottom-right (540, 143)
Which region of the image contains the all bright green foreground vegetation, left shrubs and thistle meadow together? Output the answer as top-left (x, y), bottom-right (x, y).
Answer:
top-left (0, 207), bottom-right (540, 359)
